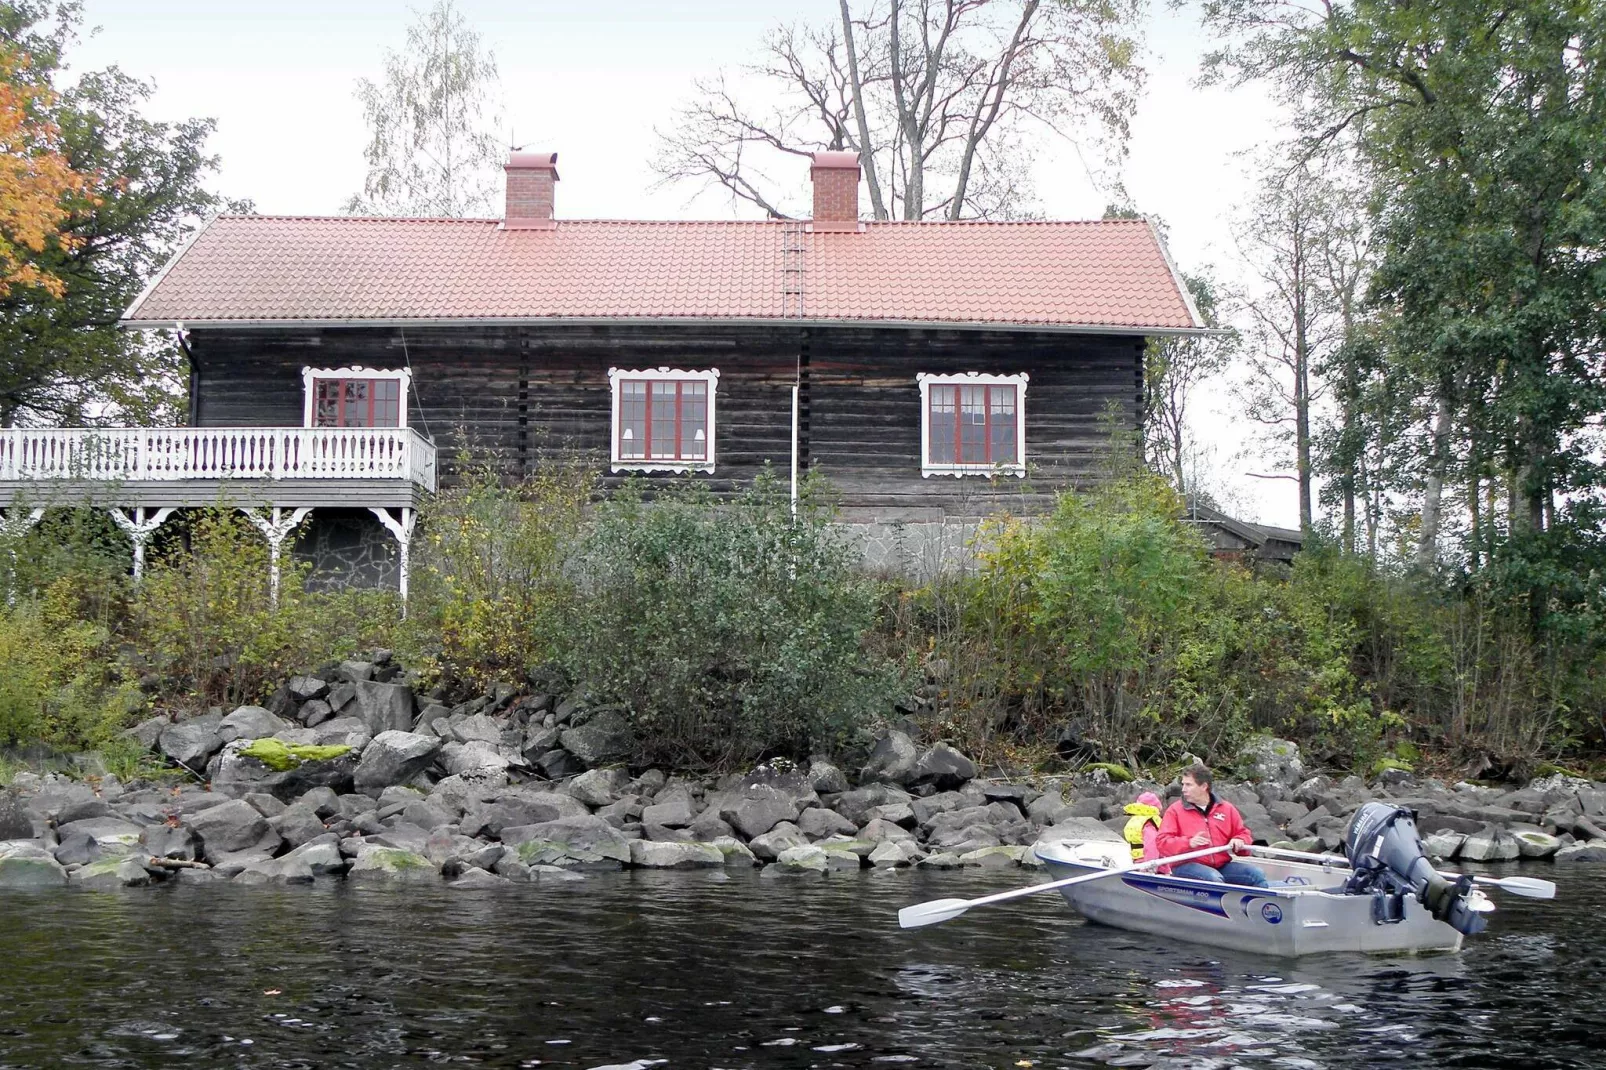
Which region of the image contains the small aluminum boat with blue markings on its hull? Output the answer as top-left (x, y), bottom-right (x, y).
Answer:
top-left (1036, 840), bottom-right (1494, 956)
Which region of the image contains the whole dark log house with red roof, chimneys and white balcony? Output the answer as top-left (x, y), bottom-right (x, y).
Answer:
top-left (0, 153), bottom-right (1205, 593)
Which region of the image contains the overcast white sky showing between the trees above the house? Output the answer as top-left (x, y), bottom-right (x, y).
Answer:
top-left (71, 0), bottom-right (1296, 525)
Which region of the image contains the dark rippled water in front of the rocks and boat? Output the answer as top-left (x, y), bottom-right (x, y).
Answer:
top-left (0, 866), bottom-right (1606, 1070)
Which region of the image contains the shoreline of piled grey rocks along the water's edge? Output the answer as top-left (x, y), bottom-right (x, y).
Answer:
top-left (0, 652), bottom-right (1606, 888)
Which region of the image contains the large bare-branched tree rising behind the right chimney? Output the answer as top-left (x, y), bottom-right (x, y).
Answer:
top-left (654, 0), bottom-right (1145, 220)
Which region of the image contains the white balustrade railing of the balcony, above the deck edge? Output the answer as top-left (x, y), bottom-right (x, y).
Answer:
top-left (0, 427), bottom-right (435, 490)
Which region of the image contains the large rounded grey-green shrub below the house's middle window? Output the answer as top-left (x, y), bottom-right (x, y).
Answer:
top-left (565, 474), bottom-right (898, 768)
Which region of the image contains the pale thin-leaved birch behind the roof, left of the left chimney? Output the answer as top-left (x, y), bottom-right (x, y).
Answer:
top-left (344, 0), bottom-right (506, 217)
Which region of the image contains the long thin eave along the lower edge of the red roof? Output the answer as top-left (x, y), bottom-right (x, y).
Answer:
top-left (117, 310), bottom-right (1230, 337)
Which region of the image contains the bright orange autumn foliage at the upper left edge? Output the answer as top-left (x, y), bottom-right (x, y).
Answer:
top-left (0, 45), bottom-right (88, 297)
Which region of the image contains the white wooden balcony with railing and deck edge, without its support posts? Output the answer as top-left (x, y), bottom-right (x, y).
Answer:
top-left (0, 427), bottom-right (435, 508)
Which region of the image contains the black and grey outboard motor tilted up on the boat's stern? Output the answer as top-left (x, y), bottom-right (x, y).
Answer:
top-left (1344, 802), bottom-right (1487, 935)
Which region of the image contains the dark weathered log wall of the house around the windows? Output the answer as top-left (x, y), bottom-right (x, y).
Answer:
top-left (191, 325), bottom-right (1142, 519)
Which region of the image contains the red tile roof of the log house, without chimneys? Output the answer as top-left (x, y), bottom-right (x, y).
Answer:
top-left (124, 215), bottom-right (1203, 333)
